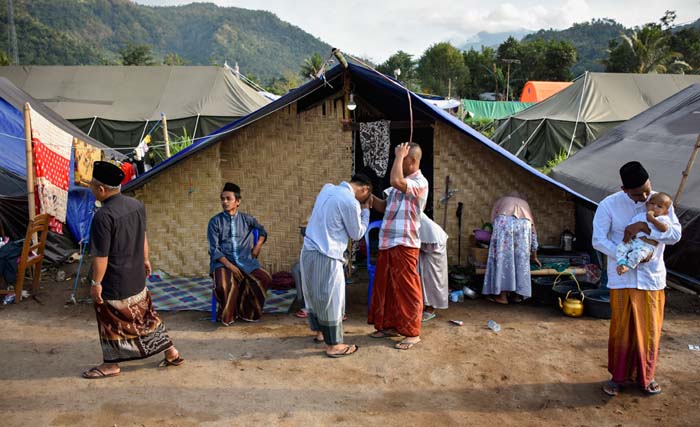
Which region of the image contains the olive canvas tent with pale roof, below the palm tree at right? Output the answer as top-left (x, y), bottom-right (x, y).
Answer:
top-left (493, 73), bottom-right (700, 167)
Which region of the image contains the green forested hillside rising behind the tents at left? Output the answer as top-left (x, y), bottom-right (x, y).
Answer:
top-left (0, 0), bottom-right (331, 81)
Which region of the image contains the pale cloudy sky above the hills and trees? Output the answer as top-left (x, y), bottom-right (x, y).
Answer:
top-left (136, 0), bottom-right (700, 62)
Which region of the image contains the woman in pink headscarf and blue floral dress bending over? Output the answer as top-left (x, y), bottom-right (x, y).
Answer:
top-left (482, 192), bottom-right (541, 304)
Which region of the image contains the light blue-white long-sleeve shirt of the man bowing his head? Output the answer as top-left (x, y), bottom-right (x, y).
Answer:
top-left (304, 182), bottom-right (369, 261)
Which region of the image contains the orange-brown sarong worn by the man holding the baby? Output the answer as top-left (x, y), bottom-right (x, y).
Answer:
top-left (608, 289), bottom-right (666, 387)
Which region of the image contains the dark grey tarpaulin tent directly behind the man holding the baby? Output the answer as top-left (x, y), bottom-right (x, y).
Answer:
top-left (551, 84), bottom-right (700, 280)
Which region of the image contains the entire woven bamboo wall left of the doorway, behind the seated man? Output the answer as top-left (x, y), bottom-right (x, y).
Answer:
top-left (131, 99), bottom-right (352, 276)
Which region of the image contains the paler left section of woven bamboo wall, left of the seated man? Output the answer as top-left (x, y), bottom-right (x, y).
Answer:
top-left (129, 145), bottom-right (221, 276)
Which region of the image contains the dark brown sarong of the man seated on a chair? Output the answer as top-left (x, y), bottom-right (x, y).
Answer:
top-left (214, 267), bottom-right (272, 325)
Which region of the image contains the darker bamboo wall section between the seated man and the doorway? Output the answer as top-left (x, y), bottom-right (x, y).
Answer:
top-left (221, 99), bottom-right (352, 272)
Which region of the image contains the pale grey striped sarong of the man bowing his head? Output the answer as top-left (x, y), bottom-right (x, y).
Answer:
top-left (300, 249), bottom-right (345, 345)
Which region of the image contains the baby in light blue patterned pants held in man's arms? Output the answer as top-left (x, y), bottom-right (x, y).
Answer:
top-left (617, 193), bottom-right (673, 274)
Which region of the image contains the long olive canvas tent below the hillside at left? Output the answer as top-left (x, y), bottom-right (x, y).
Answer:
top-left (0, 66), bottom-right (269, 147)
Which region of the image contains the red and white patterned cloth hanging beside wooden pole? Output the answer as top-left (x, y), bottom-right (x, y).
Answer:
top-left (29, 109), bottom-right (73, 234)
